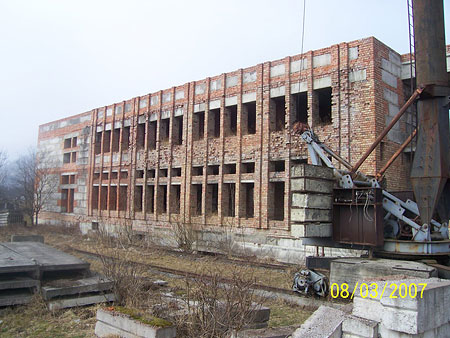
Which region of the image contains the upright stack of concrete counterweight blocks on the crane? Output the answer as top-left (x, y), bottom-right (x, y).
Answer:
top-left (291, 164), bottom-right (334, 237)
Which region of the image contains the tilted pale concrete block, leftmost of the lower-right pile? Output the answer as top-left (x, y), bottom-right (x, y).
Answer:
top-left (292, 305), bottom-right (346, 338)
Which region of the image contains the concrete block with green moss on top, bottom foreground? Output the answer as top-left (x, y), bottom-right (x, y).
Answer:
top-left (96, 309), bottom-right (176, 338)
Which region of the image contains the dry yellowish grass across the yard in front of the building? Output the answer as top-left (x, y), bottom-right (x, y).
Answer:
top-left (0, 226), bottom-right (311, 337)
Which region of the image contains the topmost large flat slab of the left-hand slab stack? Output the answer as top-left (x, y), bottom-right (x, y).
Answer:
top-left (0, 242), bottom-right (90, 272)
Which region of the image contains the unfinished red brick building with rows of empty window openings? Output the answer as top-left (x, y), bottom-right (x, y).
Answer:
top-left (38, 37), bottom-right (422, 260)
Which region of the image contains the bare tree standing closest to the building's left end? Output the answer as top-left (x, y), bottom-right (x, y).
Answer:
top-left (15, 149), bottom-right (59, 224)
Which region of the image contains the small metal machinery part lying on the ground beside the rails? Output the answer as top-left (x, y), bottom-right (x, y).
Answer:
top-left (292, 269), bottom-right (328, 297)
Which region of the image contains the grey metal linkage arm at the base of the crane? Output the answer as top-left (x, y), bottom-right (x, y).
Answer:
top-left (302, 130), bottom-right (449, 254)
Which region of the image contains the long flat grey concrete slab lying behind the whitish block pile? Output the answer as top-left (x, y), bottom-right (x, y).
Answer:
top-left (330, 258), bottom-right (437, 290)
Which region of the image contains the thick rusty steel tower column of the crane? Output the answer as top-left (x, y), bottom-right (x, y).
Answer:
top-left (411, 0), bottom-right (450, 224)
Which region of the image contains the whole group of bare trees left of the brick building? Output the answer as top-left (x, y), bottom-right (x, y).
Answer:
top-left (0, 149), bottom-right (59, 225)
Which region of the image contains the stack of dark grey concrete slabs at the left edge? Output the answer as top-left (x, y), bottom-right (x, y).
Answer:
top-left (0, 238), bottom-right (114, 310)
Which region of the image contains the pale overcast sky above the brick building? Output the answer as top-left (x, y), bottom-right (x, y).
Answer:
top-left (0, 0), bottom-right (450, 159)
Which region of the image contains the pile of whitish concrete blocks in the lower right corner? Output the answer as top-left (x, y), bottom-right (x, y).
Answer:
top-left (292, 278), bottom-right (450, 338)
